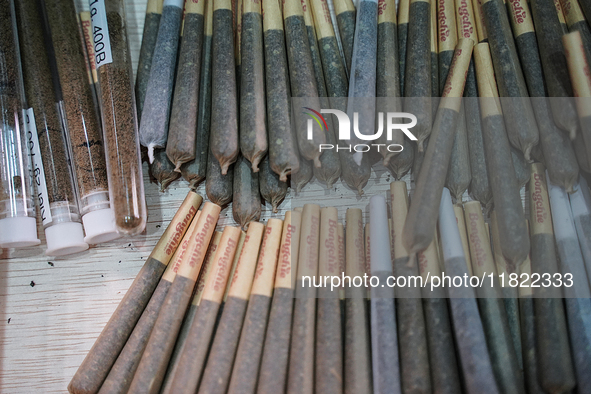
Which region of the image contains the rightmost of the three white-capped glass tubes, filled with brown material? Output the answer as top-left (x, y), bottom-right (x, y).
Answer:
top-left (42, 0), bottom-right (120, 244)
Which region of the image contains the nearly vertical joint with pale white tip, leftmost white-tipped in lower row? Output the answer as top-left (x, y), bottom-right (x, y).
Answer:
top-left (369, 195), bottom-right (402, 393)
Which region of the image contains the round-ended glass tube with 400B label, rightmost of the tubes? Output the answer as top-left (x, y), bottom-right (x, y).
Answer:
top-left (90, 0), bottom-right (147, 235)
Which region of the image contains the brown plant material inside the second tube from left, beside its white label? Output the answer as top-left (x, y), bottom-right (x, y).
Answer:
top-left (15, 0), bottom-right (77, 208)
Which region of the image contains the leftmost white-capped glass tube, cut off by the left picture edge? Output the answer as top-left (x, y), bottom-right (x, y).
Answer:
top-left (0, 0), bottom-right (41, 248)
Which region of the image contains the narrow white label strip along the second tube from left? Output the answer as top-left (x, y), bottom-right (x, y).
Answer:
top-left (24, 108), bottom-right (51, 226)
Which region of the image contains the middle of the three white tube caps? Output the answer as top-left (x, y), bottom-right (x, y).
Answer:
top-left (45, 222), bottom-right (88, 256)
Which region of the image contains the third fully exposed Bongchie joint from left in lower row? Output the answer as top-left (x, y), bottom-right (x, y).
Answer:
top-left (163, 226), bottom-right (240, 393)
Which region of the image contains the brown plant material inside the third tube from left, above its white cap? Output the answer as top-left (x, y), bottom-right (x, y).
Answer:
top-left (43, 1), bottom-right (109, 209)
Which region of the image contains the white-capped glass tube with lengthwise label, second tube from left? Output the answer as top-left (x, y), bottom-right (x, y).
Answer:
top-left (16, 0), bottom-right (88, 256)
